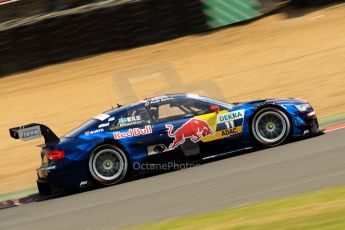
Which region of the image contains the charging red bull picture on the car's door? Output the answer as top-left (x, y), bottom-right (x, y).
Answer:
top-left (165, 118), bottom-right (213, 149)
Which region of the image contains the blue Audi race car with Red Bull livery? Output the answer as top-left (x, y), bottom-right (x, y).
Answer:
top-left (10, 94), bottom-right (321, 194)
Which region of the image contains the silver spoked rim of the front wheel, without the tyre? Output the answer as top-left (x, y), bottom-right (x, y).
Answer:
top-left (255, 111), bottom-right (288, 144)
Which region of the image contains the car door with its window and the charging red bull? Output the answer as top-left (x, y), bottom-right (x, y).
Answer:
top-left (147, 98), bottom-right (219, 157)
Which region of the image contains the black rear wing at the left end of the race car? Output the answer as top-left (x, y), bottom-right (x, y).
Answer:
top-left (9, 123), bottom-right (60, 144)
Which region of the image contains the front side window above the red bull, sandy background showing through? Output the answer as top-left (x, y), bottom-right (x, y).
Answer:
top-left (148, 99), bottom-right (212, 122)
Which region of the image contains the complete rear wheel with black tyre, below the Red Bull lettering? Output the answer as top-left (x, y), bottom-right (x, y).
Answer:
top-left (89, 145), bottom-right (128, 185)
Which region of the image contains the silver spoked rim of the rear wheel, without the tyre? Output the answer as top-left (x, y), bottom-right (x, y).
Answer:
top-left (92, 149), bottom-right (127, 182)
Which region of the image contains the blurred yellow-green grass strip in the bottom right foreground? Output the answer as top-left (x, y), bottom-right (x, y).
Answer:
top-left (128, 187), bottom-right (345, 230)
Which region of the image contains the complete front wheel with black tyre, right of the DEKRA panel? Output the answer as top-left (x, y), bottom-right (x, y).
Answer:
top-left (251, 107), bottom-right (291, 146)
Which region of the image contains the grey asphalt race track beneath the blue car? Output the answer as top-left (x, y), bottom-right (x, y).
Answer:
top-left (0, 129), bottom-right (345, 230)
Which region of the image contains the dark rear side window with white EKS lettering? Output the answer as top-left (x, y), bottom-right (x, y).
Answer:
top-left (109, 107), bottom-right (152, 130)
